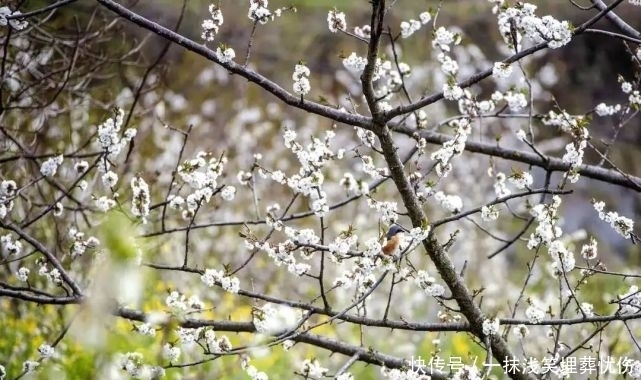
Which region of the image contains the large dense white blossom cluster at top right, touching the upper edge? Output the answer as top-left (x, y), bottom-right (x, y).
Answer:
top-left (493, 3), bottom-right (573, 50)
